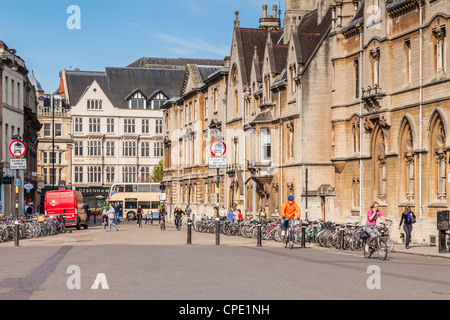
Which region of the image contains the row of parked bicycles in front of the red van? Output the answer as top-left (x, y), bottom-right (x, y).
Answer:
top-left (0, 214), bottom-right (66, 242)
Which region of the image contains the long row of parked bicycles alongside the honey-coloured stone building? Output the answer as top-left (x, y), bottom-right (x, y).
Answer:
top-left (193, 218), bottom-right (394, 252)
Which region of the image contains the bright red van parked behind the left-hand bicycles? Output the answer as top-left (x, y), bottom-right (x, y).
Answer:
top-left (44, 190), bottom-right (88, 229)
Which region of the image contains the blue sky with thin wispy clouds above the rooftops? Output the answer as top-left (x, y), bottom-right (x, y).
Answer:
top-left (0, 0), bottom-right (284, 93)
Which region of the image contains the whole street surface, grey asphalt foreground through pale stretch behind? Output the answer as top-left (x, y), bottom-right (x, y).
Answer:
top-left (0, 223), bottom-right (450, 301)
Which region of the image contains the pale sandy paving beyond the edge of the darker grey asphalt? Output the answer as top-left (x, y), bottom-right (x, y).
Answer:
top-left (0, 219), bottom-right (450, 259)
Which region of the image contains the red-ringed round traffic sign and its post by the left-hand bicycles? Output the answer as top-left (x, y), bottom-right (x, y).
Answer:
top-left (9, 139), bottom-right (27, 247)
